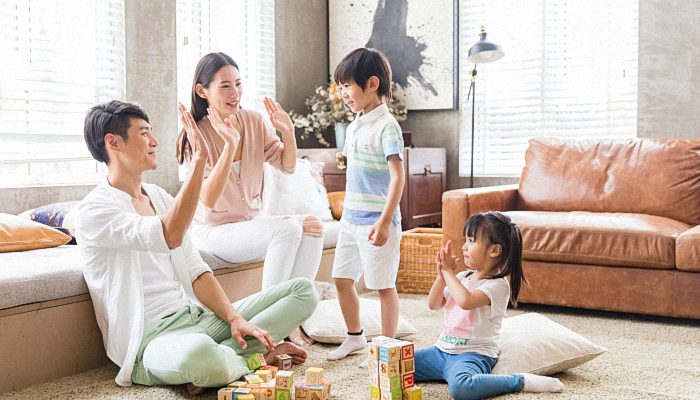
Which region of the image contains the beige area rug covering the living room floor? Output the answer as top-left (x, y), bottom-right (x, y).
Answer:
top-left (0, 294), bottom-right (700, 400)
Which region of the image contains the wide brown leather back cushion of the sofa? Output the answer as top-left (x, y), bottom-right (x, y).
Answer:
top-left (518, 138), bottom-right (700, 225)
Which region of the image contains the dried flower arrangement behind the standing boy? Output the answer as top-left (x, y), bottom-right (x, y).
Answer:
top-left (289, 83), bottom-right (407, 147)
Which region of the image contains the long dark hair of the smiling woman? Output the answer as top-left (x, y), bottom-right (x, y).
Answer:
top-left (175, 53), bottom-right (240, 164)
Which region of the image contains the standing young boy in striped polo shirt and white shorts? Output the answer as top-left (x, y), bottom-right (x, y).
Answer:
top-left (328, 48), bottom-right (404, 360)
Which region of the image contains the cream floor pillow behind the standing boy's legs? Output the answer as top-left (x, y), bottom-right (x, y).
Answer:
top-left (301, 298), bottom-right (417, 343)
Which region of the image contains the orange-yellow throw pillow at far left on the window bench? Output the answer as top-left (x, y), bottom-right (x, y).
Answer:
top-left (0, 213), bottom-right (71, 253)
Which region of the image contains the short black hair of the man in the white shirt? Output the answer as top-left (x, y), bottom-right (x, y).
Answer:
top-left (83, 100), bottom-right (150, 164)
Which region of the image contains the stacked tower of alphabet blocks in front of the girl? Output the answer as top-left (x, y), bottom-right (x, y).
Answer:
top-left (367, 336), bottom-right (423, 400)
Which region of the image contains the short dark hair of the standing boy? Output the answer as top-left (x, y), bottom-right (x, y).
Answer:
top-left (333, 47), bottom-right (392, 99)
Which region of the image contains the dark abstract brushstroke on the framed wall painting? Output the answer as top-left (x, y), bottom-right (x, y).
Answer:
top-left (365, 0), bottom-right (438, 96)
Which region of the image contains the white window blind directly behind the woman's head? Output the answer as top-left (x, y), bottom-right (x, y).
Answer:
top-left (177, 0), bottom-right (275, 111)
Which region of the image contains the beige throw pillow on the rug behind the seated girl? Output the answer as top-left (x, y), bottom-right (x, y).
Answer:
top-left (492, 313), bottom-right (607, 375)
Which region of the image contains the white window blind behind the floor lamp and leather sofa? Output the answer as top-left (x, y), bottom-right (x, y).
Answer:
top-left (459, 0), bottom-right (639, 176)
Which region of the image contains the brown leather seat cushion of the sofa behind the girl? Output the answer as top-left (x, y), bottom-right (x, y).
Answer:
top-left (505, 211), bottom-right (689, 269)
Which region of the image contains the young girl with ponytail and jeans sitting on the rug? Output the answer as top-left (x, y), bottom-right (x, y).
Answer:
top-left (415, 212), bottom-right (564, 400)
